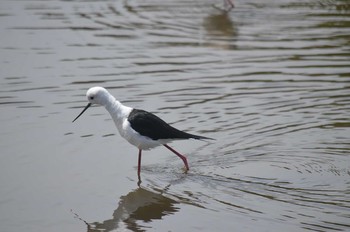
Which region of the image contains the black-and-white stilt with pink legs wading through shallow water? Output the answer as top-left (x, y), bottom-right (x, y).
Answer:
top-left (73, 87), bottom-right (211, 180)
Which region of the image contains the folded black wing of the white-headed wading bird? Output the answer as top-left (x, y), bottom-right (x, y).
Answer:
top-left (128, 109), bottom-right (210, 140)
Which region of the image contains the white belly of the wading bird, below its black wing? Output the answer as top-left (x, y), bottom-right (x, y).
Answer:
top-left (116, 119), bottom-right (164, 150)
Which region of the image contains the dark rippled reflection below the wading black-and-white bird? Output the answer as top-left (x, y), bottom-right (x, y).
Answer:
top-left (75, 187), bottom-right (178, 232)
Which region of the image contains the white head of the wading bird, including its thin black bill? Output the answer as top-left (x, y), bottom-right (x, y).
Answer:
top-left (73, 87), bottom-right (115, 122)
